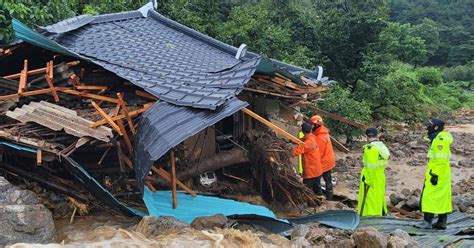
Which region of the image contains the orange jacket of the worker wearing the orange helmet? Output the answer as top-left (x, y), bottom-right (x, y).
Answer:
top-left (313, 126), bottom-right (336, 172)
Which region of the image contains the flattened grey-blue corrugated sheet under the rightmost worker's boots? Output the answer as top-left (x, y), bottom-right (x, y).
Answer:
top-left (359, 212), bottom-right (474, 247)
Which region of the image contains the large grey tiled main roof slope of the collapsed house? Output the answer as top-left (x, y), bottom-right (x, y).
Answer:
top-left (44, 10), bottom-right (260, 109)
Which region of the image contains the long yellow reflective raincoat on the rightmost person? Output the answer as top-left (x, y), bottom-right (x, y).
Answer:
top-left (420, 131), bottom-right (453, 214)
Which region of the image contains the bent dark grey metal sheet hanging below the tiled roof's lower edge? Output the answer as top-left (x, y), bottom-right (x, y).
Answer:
top-left (133, 98), bottom-right (248, 189)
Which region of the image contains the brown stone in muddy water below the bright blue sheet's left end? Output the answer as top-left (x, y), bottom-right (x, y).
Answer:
top-left (135, 216), bottom-right (189, 238)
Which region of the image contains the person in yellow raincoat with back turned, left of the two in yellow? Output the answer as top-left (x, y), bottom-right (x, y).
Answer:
top-left (357, 128), bottom-right (390, 216)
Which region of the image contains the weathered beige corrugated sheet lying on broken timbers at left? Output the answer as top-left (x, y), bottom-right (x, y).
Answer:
top-left (6, 101), bottom-right (113, 142)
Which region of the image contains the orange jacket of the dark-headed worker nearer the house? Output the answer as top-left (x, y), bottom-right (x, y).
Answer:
top-left (293, 133), bottom-right (323, 179)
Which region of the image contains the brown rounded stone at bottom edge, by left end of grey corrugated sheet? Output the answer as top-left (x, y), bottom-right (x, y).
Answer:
top-left (351, 227), bottom-right (387, 248)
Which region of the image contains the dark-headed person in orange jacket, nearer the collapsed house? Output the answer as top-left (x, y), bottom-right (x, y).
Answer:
top-left (292, 122), bottom-right (323, 192)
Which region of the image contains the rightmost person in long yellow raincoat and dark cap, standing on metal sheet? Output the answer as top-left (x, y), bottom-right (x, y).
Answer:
top-left (415, 118), bottom-right (453, 229)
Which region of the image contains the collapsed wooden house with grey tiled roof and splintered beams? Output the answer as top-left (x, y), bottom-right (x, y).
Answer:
top-left (0, 4), bottom-right (342, 215)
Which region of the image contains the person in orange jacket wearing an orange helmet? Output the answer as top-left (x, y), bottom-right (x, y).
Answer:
top-left (310, 115), bottom-right (336, 200)
